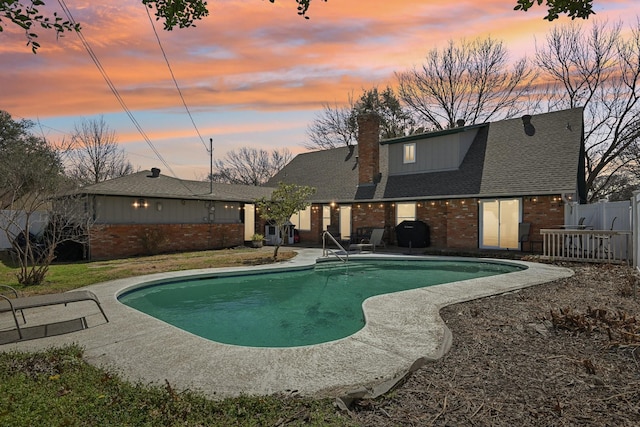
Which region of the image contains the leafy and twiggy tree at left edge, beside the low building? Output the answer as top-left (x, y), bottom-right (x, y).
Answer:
top-left (0, 114), bottom-right (89, 285)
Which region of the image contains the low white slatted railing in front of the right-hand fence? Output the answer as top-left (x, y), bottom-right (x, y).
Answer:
top-left (540, 229), bottom-right (633, 263)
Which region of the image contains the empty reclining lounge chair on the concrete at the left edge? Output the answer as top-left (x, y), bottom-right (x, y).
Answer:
top-left (0, 285), bottom-right (109, 339)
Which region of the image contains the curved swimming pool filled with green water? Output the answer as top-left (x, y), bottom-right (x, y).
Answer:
top-left (118, 259), bottom-right (524, 347)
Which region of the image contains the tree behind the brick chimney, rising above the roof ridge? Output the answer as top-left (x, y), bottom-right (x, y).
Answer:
top-left (303, 86), bottom-right (415, 150)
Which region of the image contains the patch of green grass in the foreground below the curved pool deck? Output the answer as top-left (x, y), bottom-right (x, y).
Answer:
top-left (0, 346), bottom-right (353, 427)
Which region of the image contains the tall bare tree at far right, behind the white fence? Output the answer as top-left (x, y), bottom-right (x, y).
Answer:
top-left (535, 22), bottom-right (640, 199)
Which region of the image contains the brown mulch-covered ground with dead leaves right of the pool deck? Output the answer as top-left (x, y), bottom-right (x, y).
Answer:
top-left (351, 264), bottom-right (640, 426)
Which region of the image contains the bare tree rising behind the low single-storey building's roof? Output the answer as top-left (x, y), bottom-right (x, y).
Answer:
top-left (68, 117), bottom-right (134, 185)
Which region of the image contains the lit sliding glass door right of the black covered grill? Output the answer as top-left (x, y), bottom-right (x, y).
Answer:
top-left (480, 199), bottom-right (521, 249)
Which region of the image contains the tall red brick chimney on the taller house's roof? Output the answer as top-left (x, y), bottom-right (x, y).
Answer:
top-left (358, 113), bottom-right (380, 185)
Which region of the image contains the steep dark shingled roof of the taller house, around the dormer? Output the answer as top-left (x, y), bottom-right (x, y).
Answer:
top-left (268, 108), bottom-right (583, 203)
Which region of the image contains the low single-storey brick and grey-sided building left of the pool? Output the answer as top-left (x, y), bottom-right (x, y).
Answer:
top-left (78, 168), bottom-right (273, 259)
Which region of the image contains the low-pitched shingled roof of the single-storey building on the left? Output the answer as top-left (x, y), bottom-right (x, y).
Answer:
top-left (78, 171), bottom-right (274, 202)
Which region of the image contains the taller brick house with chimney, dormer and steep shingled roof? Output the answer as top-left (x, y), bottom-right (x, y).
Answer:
top-left (267, 108), bottom-right (586, 250)
